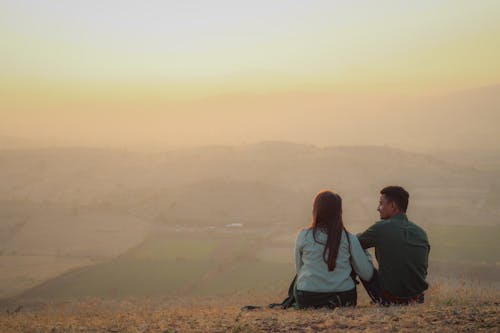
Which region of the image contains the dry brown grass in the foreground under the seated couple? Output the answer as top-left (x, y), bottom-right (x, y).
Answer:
top-left (0, 281), bottom-right (500, 332)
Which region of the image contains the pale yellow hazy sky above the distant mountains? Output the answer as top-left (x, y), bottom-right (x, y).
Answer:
top-left (0, 0), bottom-right (500, 148)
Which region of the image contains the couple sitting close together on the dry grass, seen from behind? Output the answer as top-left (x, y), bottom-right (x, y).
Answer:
top-left (293, 186), bottom-right (430, 308)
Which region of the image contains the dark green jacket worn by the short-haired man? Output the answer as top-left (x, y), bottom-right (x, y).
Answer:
top-left (358, 214), bottom-right (430, 297)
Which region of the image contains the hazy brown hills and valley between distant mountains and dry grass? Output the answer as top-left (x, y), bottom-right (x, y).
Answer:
top-left (0, 142), bottom-right (500, 298)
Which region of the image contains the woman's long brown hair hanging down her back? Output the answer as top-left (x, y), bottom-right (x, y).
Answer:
top-left (311, 191), bottom-right (347, 272)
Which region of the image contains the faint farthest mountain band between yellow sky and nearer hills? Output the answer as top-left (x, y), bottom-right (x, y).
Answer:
top-left (1, 85), bottom-right (500, 151)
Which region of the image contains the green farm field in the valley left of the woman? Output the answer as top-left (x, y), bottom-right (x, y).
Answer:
top-left (9, 231), bottom-right (293, 300)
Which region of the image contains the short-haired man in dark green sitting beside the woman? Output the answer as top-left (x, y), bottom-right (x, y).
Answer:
top-left (358, 186), bottom-right (430, 305)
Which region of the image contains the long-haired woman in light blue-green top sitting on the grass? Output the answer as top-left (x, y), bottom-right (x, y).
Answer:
top-left (294, 191), bottom-right (373, 308)
